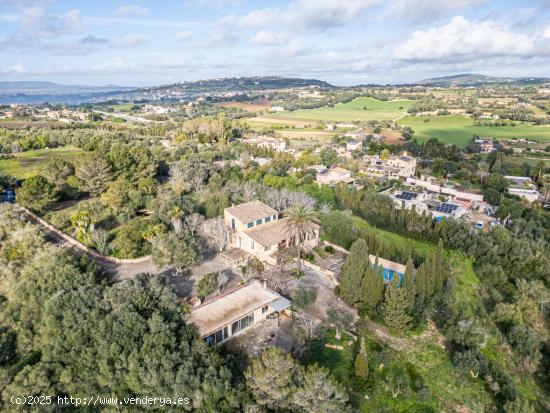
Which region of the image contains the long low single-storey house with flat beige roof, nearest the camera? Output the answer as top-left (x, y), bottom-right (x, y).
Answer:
top-left (188, 281), bottom-right (290, 344)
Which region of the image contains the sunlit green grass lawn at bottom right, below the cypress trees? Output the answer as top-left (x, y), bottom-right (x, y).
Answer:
top-left (302, 331), bottom-right (493, 413)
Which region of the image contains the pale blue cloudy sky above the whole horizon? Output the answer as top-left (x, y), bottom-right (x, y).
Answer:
top-left (0, 0), bottom-right (550, 86)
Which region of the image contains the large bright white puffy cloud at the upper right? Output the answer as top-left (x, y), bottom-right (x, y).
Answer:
top-left (394, 16), bottom-right (544, 61)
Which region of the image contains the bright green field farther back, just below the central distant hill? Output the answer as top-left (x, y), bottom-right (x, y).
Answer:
top-left (273, 97), bottom-right (414, 122)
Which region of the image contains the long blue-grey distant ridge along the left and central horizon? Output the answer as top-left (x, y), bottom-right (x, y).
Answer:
top-left (0, 76), bottom-right (333, 104)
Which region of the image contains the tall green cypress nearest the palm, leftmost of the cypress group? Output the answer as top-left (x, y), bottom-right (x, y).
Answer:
top-left (340, 238), bottom-right (369, 305)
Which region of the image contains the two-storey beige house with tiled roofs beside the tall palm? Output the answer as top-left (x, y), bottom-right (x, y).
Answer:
top-left (223, 201), bottom-right (320, 265)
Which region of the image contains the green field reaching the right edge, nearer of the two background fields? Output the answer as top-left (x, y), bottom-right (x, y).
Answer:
top-left (397, 115), bottom-right (550, 147)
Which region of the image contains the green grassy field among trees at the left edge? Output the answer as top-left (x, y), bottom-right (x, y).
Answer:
top-left (0, 146), bottom-right (84, 179)
